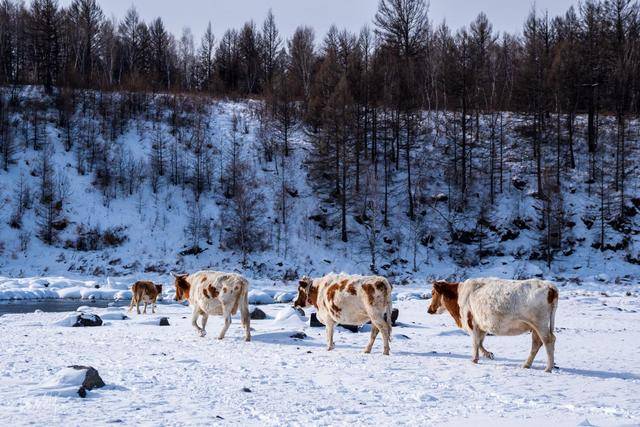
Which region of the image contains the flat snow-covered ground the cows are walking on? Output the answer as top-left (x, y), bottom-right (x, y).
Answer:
top-left (0, 285), bottom-right (640, 426)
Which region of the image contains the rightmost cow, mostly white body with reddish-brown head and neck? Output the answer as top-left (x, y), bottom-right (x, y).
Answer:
top-left (428, 278), bottom-right (559, 372)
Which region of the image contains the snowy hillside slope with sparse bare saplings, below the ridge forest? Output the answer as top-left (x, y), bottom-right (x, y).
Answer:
top-left (0, 87), bottom-right (640, 284)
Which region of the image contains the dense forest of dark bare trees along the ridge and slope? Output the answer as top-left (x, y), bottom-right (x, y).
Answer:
top-left (0, 0), bottom-right (640, 280)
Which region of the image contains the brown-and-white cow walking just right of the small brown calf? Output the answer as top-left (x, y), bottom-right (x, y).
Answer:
top-left (172, 271), bottom-right (251, 341)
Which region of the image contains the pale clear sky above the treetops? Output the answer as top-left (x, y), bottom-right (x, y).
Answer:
top-left (60, 0), bottom-right (578, 40)
